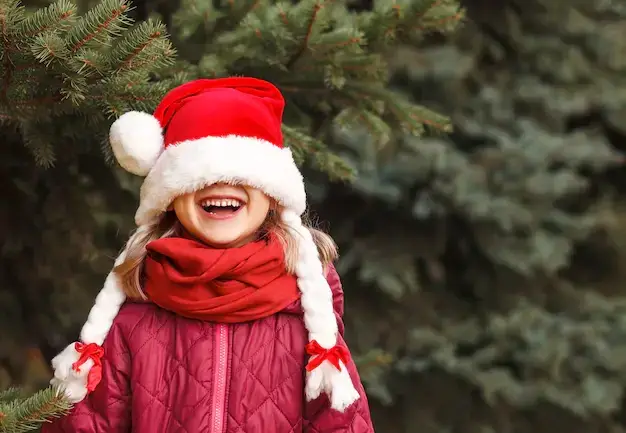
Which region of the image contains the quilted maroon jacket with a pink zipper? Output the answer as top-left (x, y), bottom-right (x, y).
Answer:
top-left (42, 268), bottom-right (374, 433)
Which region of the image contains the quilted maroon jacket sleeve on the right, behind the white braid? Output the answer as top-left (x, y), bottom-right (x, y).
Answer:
top-left (304, 266), bottom-right (374, 433)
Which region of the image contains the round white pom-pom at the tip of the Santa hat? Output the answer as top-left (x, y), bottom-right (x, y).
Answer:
top-left (109, 111), bottom-right (163, 176)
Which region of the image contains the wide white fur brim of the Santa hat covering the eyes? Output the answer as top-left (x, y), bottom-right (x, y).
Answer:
top-left (135, 135), bottom-right (306, 225)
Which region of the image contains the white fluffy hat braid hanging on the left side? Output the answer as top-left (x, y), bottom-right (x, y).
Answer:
top-left (50, 243), bottom-right (132, 403)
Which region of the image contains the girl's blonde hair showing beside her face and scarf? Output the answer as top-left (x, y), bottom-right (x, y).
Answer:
top-left (113, 205), bottom-right (338, 299)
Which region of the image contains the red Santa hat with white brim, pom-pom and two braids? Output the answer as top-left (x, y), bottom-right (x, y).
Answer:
top-left (51, 77), bottom-right (359, 411)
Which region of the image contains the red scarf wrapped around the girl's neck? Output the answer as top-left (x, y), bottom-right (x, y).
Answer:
top-left (144, 238), bottom-right (299, 323)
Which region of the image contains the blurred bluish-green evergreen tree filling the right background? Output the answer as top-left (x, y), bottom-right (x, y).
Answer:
top-left (313, 0), bottom-right (626, 426)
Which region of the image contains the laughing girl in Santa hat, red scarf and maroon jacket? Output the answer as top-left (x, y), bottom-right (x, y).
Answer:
top-left (42, 78), bottom-right (374, 433)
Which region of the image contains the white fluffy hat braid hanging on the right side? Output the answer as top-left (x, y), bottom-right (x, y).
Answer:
top-left (281, 209), bottom-right (359, 412)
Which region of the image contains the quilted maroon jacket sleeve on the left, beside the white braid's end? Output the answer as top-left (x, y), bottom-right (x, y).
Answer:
top-left (41, 322), bottom-right (131, 433)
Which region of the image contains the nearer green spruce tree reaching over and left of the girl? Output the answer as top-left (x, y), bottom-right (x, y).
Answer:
top-left (0, 0), bottom-right (462, 431)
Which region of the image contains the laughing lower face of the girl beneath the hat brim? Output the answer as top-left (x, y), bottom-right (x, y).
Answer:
top-left (173, 183), bottom-right (270, 248)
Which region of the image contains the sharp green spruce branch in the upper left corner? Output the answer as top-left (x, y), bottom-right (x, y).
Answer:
top-left (0, 0), bottom-right (173, 167)
